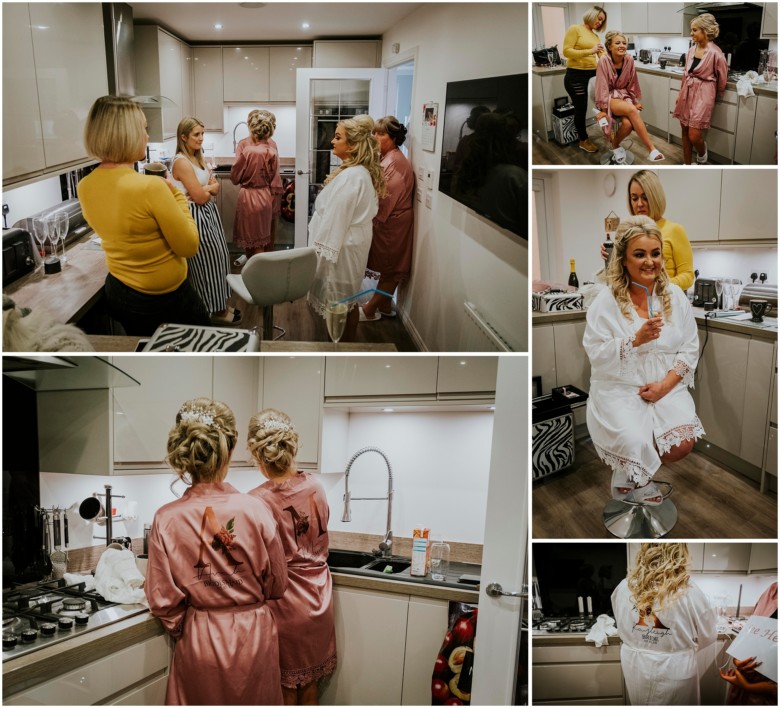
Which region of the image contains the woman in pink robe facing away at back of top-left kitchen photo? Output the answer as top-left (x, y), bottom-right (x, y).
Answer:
top-left (230, 110), bottom-right (283, 258)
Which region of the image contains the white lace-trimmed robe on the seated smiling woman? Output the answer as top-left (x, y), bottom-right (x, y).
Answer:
top-left (582, 284), bottom-right (704, 484)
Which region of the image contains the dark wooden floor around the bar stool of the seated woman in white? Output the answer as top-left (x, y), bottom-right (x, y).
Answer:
top-left (531, 439), bottom-right (777, 539)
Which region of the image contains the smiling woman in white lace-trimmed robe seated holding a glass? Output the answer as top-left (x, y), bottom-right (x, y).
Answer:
top-left (583, 216), bottom-right (704, 504)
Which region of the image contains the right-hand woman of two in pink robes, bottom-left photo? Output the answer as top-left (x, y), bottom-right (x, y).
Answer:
top-left (247, 408), bottom-right (336, 705)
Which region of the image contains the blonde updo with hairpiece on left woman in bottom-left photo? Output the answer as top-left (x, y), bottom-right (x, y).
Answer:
top-left (165, 398), bottom-right (238, 484)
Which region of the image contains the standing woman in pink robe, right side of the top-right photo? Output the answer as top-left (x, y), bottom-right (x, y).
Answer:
top-left (672, 12), bottom-right (729, 165)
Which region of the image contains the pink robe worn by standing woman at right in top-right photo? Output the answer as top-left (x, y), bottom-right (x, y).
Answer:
top-left (672, 42), bottom-right (729, 129)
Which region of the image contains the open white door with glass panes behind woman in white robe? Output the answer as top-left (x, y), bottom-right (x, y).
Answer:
top-left (295, 69), bottom-right (387, 247)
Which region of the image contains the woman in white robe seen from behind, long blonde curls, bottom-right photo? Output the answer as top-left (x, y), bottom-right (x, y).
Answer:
top-left (612, 543), bottom-right (718, 706)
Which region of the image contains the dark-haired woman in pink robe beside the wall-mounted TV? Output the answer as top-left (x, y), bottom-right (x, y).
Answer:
top-left (360, 116), bottom-right (414, 322)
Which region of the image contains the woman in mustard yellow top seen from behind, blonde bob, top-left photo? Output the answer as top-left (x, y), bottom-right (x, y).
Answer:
top-left (78, 96), bottom-right (209, 335)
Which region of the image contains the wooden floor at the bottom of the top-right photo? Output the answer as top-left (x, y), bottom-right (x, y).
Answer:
top-left (532, 123), bottom-right (683, 165)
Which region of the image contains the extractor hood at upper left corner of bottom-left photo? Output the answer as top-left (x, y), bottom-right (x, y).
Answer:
top-left (3, 355), bottom-right (141, 391)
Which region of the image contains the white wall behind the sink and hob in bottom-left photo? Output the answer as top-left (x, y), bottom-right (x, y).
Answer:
top-left (41, 411), bottom-right (493, 548)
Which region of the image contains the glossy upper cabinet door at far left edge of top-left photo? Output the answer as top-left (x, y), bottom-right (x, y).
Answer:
top-left (3, 3), bottom-right (46, 181)
